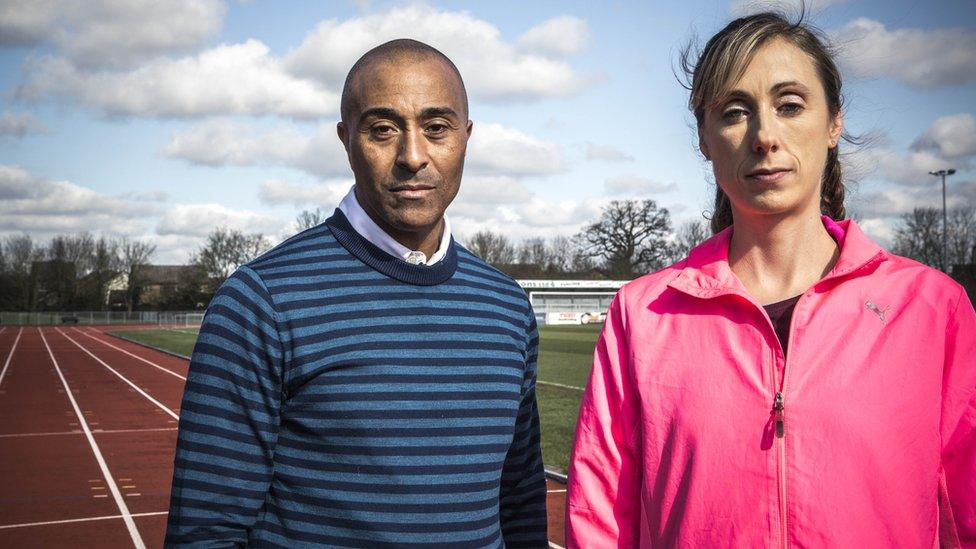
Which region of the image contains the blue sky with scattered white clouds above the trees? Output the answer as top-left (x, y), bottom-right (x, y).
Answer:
top-left (0, 0), bottom-right (976, 263)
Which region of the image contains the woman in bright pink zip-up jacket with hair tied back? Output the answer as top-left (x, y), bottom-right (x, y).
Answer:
top-left (567, 13), bottom-right (976, 547)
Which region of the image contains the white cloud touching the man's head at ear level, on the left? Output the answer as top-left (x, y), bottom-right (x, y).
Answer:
top-left (163, 120), bottom-right (350, 177)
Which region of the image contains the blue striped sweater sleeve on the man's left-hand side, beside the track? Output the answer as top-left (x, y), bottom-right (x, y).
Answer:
top-left (165, 267), bottom-right (282, 547)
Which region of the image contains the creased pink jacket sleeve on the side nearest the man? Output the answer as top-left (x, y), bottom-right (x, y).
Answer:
top-left (566, 289), bottom-right (641, 548)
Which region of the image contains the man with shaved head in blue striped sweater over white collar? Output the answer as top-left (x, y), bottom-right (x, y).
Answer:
top-left (166, 40), bottom-right (547, 548)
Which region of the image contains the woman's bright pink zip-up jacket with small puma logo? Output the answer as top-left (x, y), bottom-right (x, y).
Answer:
top-left (566, 218), bottom-right (976, 548)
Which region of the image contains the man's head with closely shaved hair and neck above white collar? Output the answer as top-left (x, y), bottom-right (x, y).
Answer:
top-left (337, 39), bottom-right (471, 255)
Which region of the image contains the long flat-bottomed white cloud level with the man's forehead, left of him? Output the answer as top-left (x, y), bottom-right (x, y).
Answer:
top-left (19, 40), bottom-right (339, 118)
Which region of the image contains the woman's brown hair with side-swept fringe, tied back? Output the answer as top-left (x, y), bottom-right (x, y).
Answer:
top-left (681, 12), bottom-right (845, 233)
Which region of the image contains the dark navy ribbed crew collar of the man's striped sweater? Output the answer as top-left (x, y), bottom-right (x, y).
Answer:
top-left (325, 209), bottom-right (457, 286)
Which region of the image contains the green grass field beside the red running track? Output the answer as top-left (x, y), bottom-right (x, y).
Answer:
top-left (115, 325), bottom-right (601, 471)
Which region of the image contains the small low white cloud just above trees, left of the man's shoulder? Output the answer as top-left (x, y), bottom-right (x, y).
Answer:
top-left (156, 204), bottom-right (285, 237)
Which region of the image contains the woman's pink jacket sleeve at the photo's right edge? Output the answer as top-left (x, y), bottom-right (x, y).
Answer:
top-left (939, 289), bottom-right (976, 547)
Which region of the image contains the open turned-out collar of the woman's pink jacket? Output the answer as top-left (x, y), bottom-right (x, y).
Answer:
top-left (668, 215), bottom-right (888, 300)
